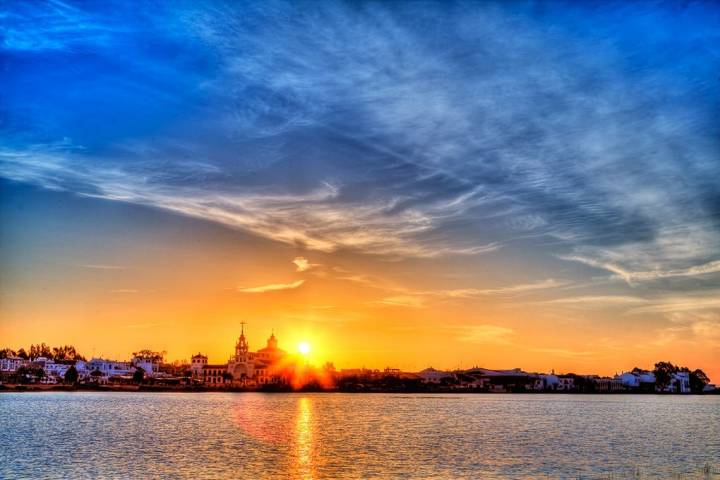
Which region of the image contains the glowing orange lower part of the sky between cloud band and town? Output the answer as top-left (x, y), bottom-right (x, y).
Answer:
top-left (0, 185), bottom-right (720, 379)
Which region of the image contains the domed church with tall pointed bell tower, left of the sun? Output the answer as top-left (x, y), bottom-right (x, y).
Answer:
top-left (190, 323), bottom-right (287, 386)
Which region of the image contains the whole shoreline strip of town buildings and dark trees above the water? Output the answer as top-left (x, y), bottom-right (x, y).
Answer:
top-left (0, 334), bottom-right (720, 394)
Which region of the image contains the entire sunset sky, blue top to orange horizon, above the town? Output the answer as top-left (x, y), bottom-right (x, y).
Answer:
top-left (0, 1), bottom-right (720, 381)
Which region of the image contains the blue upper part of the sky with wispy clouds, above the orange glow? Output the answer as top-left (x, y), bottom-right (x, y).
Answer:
top-left (0, 1), bottom-right (720, 374)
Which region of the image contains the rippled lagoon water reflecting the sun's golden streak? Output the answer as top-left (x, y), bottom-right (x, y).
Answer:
top-left (0, 392), bottom-right (720, 479)
